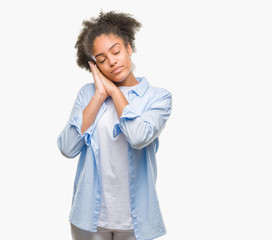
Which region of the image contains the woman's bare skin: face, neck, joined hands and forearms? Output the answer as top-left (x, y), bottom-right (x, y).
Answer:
top-left (81, 34), bottom-right (138, 133)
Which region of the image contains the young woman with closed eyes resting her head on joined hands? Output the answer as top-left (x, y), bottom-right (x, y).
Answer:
top-left (57, 11), bottom-right (172, 240)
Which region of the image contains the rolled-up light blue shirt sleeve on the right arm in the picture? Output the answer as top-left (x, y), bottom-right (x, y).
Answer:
top-left (116, 90), bottom-right (172, 149)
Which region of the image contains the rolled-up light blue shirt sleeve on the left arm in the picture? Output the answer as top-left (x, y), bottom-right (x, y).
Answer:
top-left (57, 83), bottom-right (94, 158)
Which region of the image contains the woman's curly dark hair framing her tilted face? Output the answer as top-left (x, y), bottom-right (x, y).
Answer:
top-left (75, 11), bottom-right (142, 72)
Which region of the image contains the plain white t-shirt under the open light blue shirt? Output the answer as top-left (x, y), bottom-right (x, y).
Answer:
top-left (97, 87), bottom-right (133, 230)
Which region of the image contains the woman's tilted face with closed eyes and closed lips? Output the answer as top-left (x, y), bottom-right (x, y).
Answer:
top-left (92, 34), bottom-right (132, 83)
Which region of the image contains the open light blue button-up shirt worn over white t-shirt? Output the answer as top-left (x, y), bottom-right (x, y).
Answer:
top-left (57, 77), bottom-right (172, 240)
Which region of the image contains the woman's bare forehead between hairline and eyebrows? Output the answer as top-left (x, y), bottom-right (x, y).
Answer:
top-left (93, 34), bottom-right (124, 55)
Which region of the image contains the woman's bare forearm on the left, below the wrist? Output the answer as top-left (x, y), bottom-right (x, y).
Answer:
top-left (81, 93), bottom-right (105, 133)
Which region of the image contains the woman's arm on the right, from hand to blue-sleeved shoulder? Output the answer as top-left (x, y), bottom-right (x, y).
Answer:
top-left (91, 64), bottom-right (172, 149)
